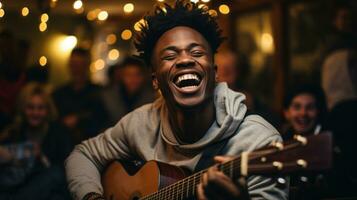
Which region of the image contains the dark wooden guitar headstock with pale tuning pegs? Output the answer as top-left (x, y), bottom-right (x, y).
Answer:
top-left (241, 133), bottom-right (332, 174)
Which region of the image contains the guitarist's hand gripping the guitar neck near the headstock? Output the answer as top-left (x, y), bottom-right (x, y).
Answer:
top-left (197, 156), bottom-right (250, 200)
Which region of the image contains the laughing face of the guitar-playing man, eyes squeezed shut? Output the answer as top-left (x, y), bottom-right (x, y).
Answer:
top-left (151, 26), bottom-right (215, 108)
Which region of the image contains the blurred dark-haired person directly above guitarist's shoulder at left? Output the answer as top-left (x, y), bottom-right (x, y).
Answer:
top-left (102, 57), bottom-right (155, 124)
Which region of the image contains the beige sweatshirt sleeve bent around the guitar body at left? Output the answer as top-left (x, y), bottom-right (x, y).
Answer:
top-left (65, 119), bottom-right (130, 200)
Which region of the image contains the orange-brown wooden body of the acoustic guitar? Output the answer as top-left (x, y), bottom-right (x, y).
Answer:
top-left (102, 161), bottom-right (188, 200)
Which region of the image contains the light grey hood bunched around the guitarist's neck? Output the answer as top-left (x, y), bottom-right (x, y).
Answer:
top-left (160, 83), bottom-right (247, 150)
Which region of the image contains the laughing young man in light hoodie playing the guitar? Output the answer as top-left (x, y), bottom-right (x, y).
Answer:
top-left (66, 1), bottom-right (287, 199)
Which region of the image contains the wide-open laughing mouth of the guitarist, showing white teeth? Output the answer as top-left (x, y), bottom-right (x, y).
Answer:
top-left (174, 73), bottom-right (202, 89)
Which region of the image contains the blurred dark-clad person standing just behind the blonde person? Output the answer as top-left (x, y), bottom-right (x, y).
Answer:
top-left (53, 48), bottom-right (107, 143)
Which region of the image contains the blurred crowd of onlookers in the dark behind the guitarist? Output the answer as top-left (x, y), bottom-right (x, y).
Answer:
top-left (0, 2), bottom-right (357, 199)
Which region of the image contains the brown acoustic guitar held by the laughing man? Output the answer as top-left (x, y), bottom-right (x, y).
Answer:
top-left (102, 133), bottom-right (332, 200)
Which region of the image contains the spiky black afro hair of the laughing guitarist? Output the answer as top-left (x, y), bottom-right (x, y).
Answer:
top-left (134, 0), bottom-right (224, 69)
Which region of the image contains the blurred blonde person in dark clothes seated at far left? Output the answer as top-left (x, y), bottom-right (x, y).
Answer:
top-left (0, 83), bottom-right (73, 200)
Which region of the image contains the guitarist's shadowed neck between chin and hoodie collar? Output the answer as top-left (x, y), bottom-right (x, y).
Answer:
top-left (168, 98), bottom-right (216, 144)
